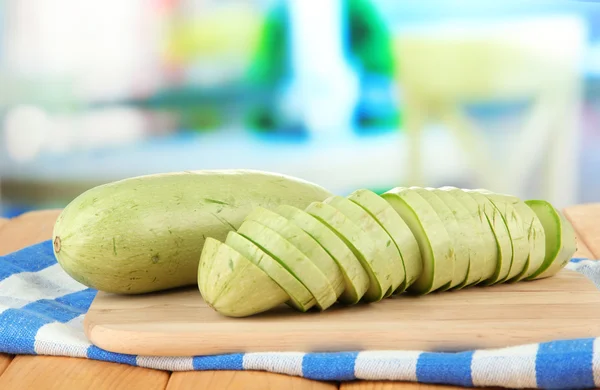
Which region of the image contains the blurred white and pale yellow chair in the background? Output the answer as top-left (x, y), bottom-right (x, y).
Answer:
top-left (394, 17), bottom-right (585, 207)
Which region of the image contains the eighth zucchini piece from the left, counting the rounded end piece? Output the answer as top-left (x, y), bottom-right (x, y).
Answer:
top-left (348, 189), bottom-right (423, 293)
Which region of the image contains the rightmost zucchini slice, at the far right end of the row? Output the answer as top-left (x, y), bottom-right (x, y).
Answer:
top-left (525, 200), bottom-right (577, 280)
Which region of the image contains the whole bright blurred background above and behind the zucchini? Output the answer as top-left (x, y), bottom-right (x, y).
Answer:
top-left (0, 0), bottom-right (600, 217)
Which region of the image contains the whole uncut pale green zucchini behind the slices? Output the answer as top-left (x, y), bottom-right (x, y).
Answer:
top-left (53, 170), bottom-right (331, 294)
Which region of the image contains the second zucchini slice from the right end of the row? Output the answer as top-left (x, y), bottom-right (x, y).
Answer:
top-left (477, 189), bottom-right (546, 281)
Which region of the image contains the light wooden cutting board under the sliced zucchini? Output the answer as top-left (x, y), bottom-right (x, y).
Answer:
top-left (85, 270), bottom-right (600, 356)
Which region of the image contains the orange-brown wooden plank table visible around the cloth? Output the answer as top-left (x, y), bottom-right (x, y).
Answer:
top-left (0, 203), bottom-right (600, 390)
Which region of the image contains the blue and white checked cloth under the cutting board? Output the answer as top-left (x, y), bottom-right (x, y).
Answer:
top-left (0, 241), bottom-right (600, 389)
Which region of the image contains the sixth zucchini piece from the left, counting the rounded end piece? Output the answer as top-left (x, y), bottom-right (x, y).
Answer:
top-left (306, 202), bottom-right (392, 302)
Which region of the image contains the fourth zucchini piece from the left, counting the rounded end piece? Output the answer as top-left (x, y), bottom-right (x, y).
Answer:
top-left (246, 207), bottom-right (344, 297)
